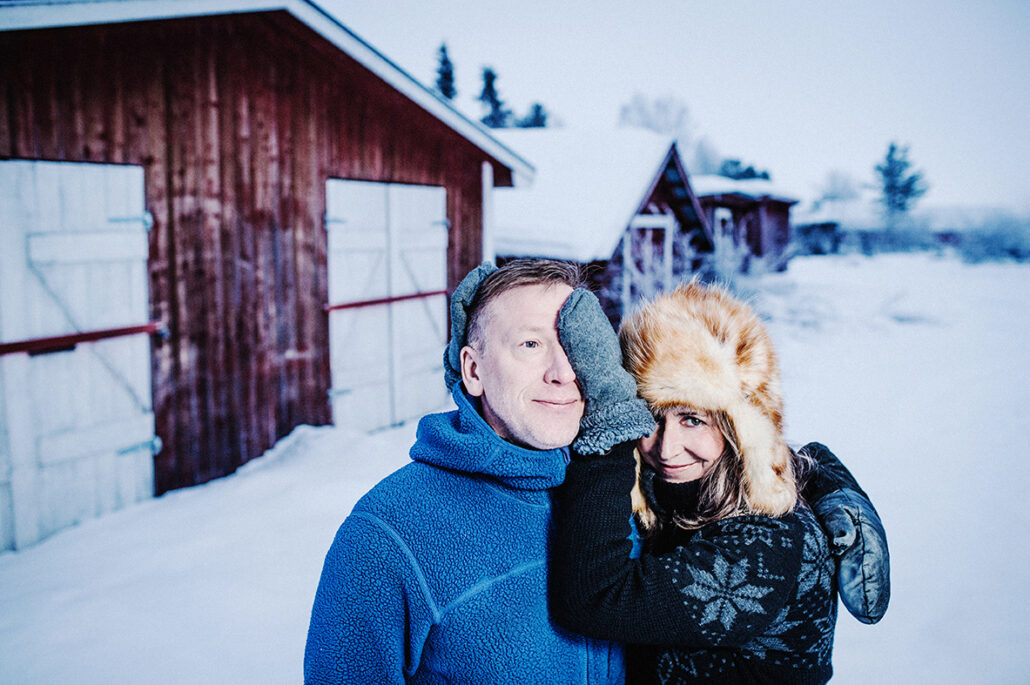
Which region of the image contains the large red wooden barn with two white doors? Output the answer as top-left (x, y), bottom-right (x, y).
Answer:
top-left (0, 0), bottom-right (534, 549)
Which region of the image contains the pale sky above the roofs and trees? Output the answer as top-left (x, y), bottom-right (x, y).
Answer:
top-left (316, 0), bottom-right (1030, 212)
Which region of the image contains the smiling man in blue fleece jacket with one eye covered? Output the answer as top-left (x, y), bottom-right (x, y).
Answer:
top-left (304, 261), bottom-right (886, 685)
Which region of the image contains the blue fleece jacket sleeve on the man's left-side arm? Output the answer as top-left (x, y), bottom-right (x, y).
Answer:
top-left (304, 512), bottom-right (435, 685)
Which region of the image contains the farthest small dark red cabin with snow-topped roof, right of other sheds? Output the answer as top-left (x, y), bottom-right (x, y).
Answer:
top-left (693, 175), bottom-right (797, 273)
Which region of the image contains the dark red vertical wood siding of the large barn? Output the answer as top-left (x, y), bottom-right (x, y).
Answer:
top-left (0, 13), bottom-right (498, 493)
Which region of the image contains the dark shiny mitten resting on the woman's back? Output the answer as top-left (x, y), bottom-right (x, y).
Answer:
top-left (802, 443), bottom-right (891, 623)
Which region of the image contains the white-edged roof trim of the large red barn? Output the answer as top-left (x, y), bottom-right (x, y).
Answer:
top-left (0, 0), bottom-right (535, 185)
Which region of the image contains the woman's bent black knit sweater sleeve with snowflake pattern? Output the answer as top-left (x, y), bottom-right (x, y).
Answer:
top-left (549, 443), bottom-right (803, 648)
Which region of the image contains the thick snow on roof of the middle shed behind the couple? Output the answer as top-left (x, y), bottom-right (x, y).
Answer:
top-left (493, 128), bottom-right (674, 262)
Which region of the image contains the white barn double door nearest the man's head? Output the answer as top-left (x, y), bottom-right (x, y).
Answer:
top-left (325, 179), bottom-right (447, 431)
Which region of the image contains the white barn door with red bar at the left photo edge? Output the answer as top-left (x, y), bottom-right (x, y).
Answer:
top-left (0, 161), bottom-right (158, 549)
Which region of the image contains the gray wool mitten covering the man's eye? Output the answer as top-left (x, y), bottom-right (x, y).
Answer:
top-left (558, 288), bottom-right (655, 454)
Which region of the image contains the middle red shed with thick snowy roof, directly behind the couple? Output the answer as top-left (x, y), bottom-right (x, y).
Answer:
top-left (493, 128), bottom-right (713, 324)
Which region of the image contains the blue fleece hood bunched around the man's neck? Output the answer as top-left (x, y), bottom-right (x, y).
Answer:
top-left (410, 381), bottom-right (569, 490)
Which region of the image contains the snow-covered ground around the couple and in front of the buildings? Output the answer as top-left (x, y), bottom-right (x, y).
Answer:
top-left (0, 255), bottom-right (1030, 685)
